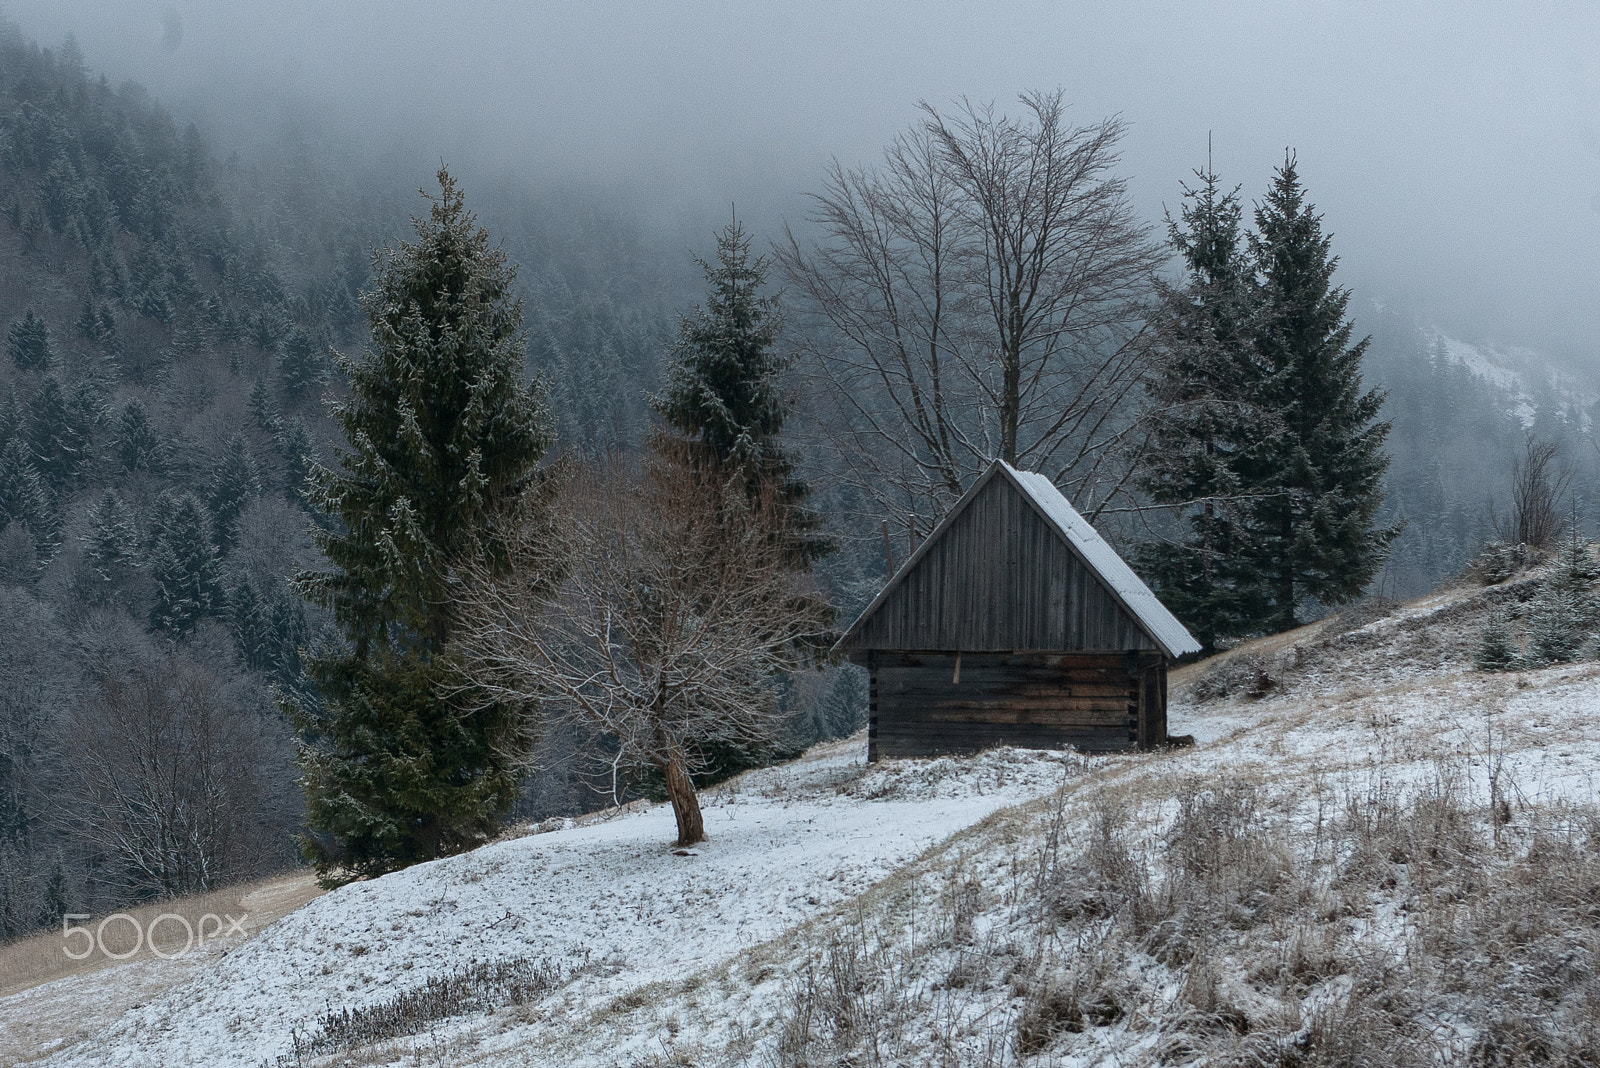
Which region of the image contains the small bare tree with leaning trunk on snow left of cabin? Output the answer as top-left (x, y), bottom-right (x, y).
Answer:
top-left (461, 456), bottom-right (827, 846)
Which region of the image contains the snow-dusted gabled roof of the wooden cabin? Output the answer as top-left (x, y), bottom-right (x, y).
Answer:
top-left (834, 460), bottom-right (1200, 657)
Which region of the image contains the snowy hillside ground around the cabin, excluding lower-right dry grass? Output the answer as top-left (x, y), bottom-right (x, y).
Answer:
top-left (12, 578), bottom-right (1600, 1068)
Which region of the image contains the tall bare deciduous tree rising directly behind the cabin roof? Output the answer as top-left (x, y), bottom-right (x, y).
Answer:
top-left (778, 91), bottom-right (1162, 518)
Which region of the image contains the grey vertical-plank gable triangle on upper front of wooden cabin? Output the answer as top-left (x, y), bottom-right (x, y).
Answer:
top-left (850, 478), bottom-right (1157, 651)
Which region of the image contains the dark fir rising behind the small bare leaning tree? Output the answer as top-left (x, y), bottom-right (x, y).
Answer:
top-left (651, 221), bottom-right (834, 571)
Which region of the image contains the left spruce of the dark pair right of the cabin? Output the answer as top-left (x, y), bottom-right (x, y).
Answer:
top-left (1139, 168), bottom-right (1266, 649)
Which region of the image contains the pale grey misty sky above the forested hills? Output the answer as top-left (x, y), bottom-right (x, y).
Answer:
top-left (12, 0), bottom-right (1600, 358)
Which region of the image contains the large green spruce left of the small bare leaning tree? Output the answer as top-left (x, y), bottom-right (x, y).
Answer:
top-left (288, 169), bottom-right (547, 883)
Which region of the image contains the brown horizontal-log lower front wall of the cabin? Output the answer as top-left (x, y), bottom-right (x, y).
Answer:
top-left (867, 652), bottom-right (1166, 761)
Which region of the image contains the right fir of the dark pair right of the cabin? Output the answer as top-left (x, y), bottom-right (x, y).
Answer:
top-left (1240, 155), bottom-right (1400, 630)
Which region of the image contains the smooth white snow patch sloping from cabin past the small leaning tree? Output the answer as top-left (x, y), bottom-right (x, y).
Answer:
top-left (0, 739), bottom-right (1064, 1068)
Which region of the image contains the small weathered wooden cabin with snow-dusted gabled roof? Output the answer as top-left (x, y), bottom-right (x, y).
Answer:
top-left (835, 460), bottom-right (1200, 761)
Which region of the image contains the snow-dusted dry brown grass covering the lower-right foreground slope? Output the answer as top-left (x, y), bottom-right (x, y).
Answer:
top-left (770, 766), bottom-right (1600, 1068)
